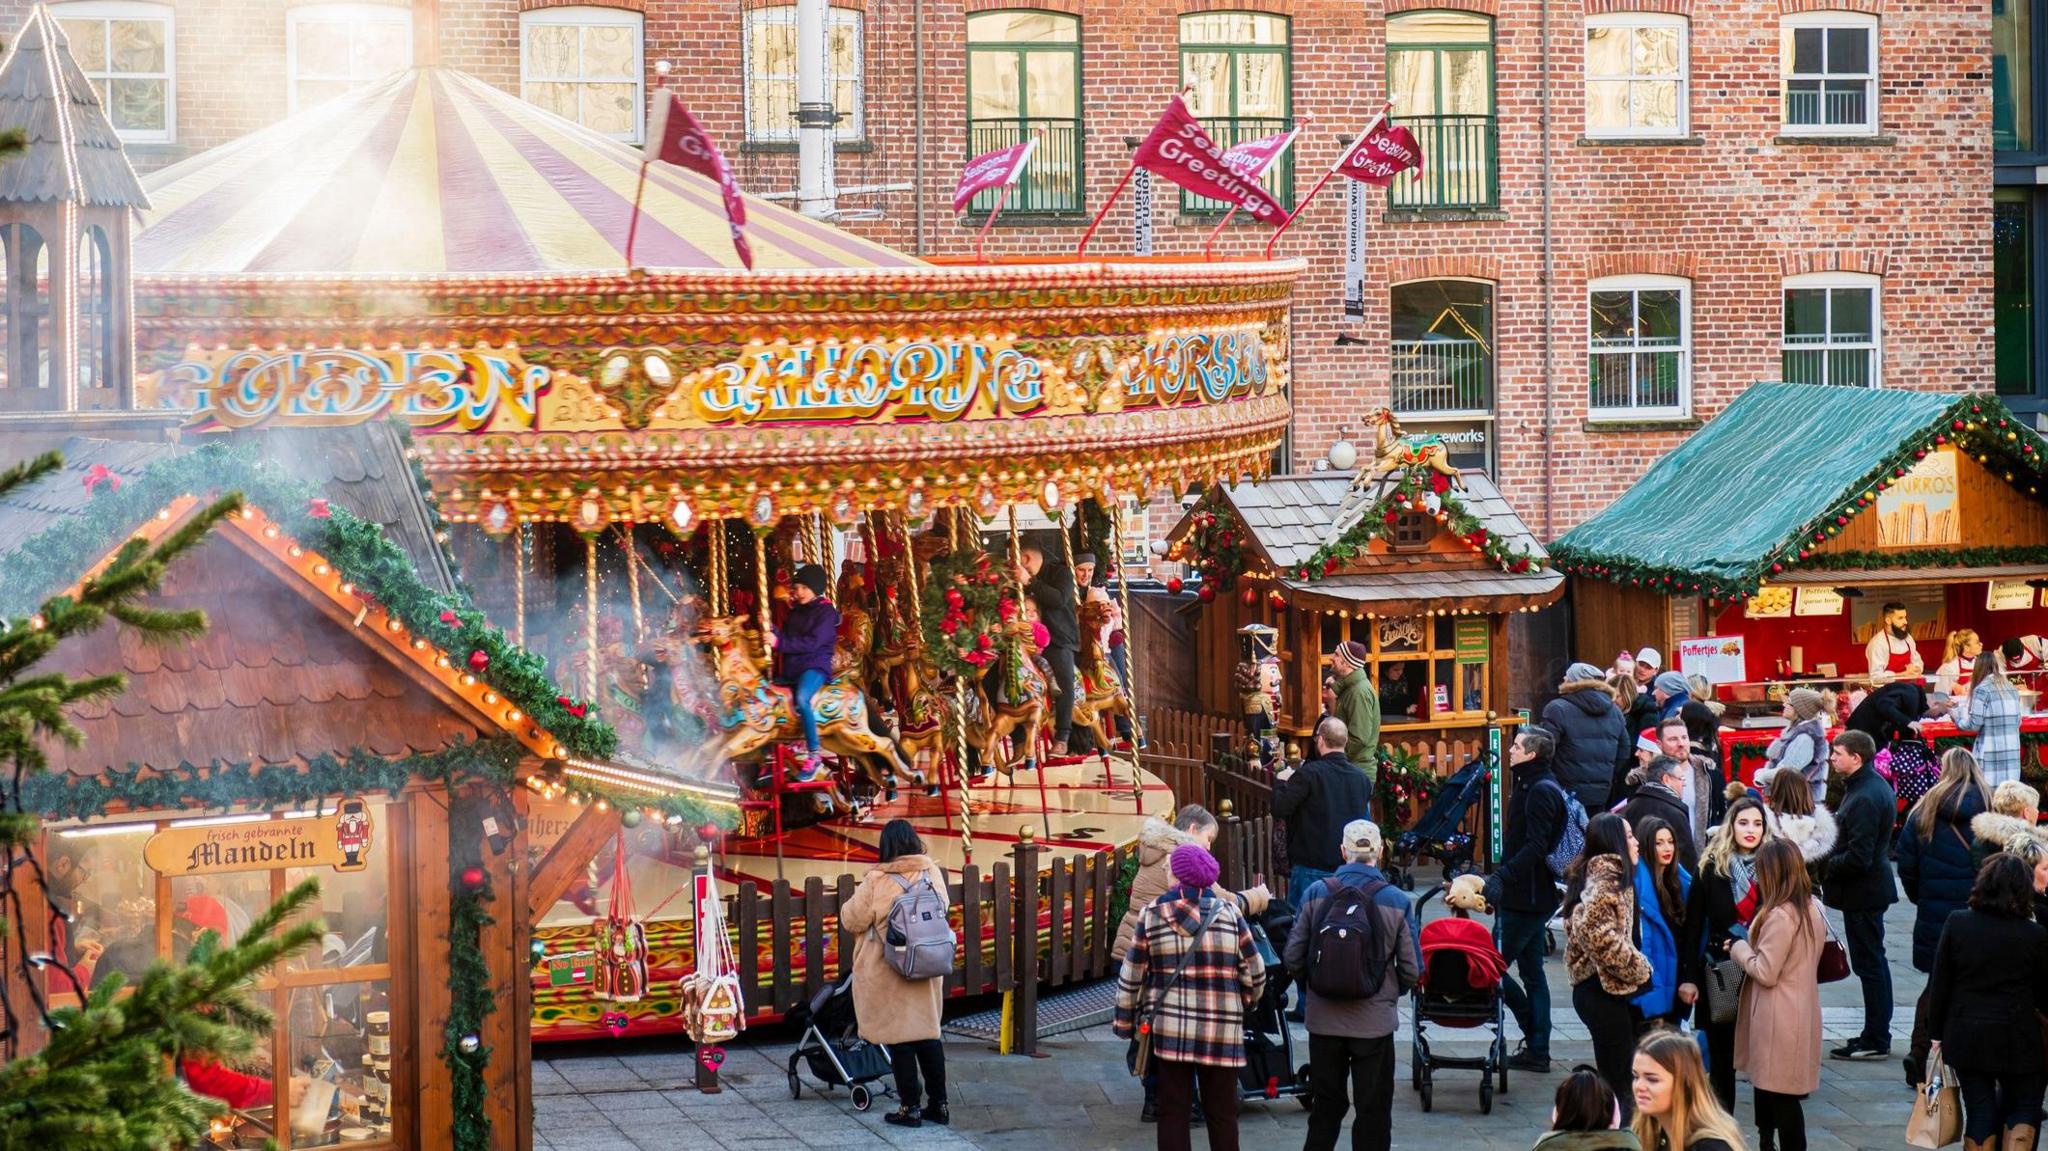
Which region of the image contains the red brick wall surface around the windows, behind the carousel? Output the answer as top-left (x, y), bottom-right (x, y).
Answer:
top-left (0, 0), bottom-right (1993, 537)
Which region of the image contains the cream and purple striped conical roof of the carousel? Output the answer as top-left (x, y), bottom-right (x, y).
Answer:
top-left (135, 68), bottom-right (918, 276)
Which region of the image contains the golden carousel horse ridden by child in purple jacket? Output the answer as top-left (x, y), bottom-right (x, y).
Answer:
top-left (696, 616), bottom-right (930, 799)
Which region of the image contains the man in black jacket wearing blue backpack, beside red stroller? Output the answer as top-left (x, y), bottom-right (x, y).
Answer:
top-left (1458, 727), bottom-right (1585, 1071)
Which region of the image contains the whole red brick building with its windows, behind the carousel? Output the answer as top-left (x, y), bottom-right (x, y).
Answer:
top-left (0, 0), bottom-right (1993, 539)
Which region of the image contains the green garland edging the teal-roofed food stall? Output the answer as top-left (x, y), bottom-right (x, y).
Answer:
top-left (1552, 393), bottom-right (2048, 602)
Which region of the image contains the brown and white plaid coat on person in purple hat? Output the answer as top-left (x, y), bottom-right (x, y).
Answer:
top-left (1114, 887), bottom-right (1266, 1067)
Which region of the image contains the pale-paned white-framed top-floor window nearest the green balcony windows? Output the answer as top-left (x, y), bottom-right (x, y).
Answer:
top-left (1585, 12), bottom-right (1690, 137)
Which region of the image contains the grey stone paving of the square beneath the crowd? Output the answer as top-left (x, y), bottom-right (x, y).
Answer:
top-left (535, 880), bottom-right (1921, 1151)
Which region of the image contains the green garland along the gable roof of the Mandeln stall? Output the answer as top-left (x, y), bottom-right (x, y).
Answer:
top-left (0, 442), bottom-right (618, 760)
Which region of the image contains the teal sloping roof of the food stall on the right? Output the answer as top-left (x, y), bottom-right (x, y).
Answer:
top-left (1550, 383), bottom-right (2048, 594)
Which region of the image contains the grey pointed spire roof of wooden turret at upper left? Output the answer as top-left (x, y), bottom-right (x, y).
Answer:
top-left (0, 4), bottom-right (147, 207)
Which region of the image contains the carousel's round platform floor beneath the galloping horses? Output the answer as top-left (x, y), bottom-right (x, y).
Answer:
top-left (719, 756), bottom-right (1174, 887)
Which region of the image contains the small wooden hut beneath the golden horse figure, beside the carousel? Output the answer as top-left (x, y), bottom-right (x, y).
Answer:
top-left (1167, 452), bottom-right (1565, 772)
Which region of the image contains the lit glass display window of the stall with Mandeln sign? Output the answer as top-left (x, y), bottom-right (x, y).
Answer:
top-left (45, 799), bottom-right (406, 1151)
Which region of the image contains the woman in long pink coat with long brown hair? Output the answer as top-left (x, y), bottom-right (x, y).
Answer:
top-left (1729, 840), bottom-right (1827, 1151)
